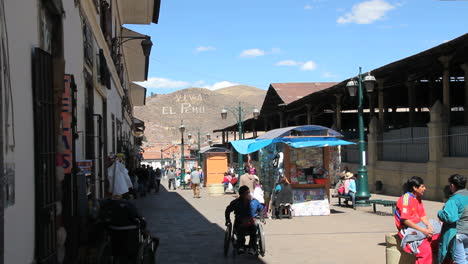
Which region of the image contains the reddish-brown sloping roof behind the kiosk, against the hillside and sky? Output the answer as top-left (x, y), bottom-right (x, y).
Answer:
top-left (270, 82), bottom-right (337, 104)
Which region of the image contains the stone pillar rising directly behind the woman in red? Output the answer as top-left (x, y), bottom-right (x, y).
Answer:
top-left (425, 100), bottom-right (447, 200)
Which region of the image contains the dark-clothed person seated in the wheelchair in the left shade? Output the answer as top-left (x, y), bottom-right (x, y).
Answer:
top-left (100, 195), bottom-right (146, 264)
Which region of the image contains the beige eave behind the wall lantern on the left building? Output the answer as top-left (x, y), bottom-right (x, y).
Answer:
top-left (122, 27), bottom-right (149, 82)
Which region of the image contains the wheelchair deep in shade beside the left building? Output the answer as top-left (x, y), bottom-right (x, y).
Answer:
top-left (97, 218), bottom-right (159, 264)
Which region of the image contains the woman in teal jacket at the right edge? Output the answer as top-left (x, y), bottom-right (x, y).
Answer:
top-left (437, 174), bottom-right (468, 264)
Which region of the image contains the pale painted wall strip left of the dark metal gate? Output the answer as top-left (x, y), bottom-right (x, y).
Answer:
top-left (5, 0), bottom-right (39, 263)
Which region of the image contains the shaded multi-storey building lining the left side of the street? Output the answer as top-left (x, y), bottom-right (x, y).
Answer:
top-left (0, 0), bottom-right (160, 263)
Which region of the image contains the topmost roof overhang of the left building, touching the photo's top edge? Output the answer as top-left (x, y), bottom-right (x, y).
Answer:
top-left (119, 0), bottom-right (161, 24)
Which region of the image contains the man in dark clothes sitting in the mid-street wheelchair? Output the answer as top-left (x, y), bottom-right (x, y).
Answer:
top-left (224, 185), bottom-right (263, 254)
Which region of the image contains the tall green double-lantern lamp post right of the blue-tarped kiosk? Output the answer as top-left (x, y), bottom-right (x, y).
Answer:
top-left (346, 67), bottom-right (376, 206)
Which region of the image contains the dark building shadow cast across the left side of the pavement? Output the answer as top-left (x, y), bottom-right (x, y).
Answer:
top-left (135, 185), bottom-right (268, 264)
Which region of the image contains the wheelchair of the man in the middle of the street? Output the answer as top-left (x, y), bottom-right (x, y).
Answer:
top-left (224, 217), bottom-right (266, 257)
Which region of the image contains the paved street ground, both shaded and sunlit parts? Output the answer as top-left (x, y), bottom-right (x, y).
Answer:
top-left (136, 183), bottom-right (443, 264)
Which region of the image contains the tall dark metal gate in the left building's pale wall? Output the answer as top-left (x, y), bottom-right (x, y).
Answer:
top-left (33, 48), bottom-right (57, 264)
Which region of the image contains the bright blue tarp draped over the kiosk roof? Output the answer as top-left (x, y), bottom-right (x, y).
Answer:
top-left (231, 137), bottom-right (356, 154)
